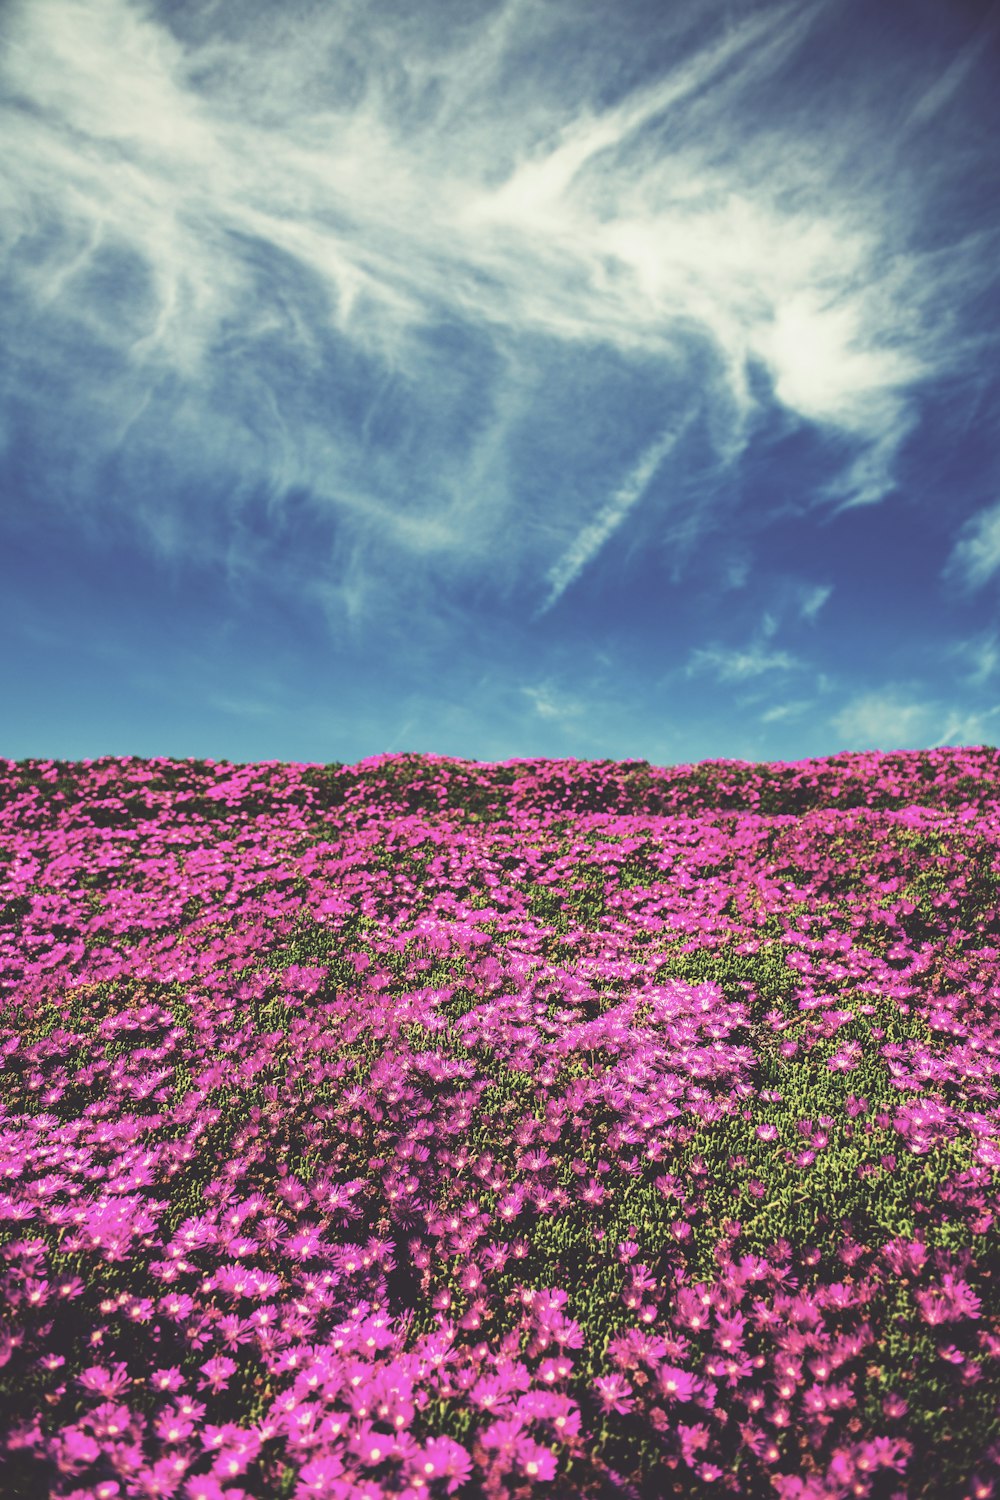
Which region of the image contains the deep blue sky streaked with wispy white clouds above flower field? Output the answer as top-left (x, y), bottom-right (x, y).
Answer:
top-left (0, 0), bottom-right (1000, 765)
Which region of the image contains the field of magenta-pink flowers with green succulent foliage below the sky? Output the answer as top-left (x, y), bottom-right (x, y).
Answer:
top-left (0, 750), bottom-right (1000, 1500)
